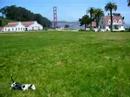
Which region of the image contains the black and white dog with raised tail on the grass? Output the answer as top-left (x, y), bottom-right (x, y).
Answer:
top-left (11, 76), bottom-right (36, 91)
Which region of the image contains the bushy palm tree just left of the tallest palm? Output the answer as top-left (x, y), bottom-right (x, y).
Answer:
top-left (94, 8), bottom-right (104, 28)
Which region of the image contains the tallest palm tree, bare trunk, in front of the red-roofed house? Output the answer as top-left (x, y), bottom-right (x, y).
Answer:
top-left (105, 2), bottom-right (117, 31)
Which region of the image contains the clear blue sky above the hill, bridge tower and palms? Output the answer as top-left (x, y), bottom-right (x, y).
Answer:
top-left (0, 0), bottom-right (130, 24)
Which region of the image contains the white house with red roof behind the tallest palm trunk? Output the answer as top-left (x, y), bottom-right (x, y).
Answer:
top-left (100, 15), bottom-right (125, 31)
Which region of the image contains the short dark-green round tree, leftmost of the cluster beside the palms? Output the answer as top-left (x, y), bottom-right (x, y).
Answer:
top-left (79, 15), bottom-right (91, 30)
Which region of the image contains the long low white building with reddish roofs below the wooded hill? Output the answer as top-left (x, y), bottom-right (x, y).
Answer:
top-left (0, 21), bottom-right (43, 32)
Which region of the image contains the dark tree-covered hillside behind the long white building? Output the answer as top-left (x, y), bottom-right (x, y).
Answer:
top-left (0, 5), bottom-right (51, 27)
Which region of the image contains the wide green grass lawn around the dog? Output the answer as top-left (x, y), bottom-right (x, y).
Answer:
top-left (0, 32), bottom-right (130, 97)
